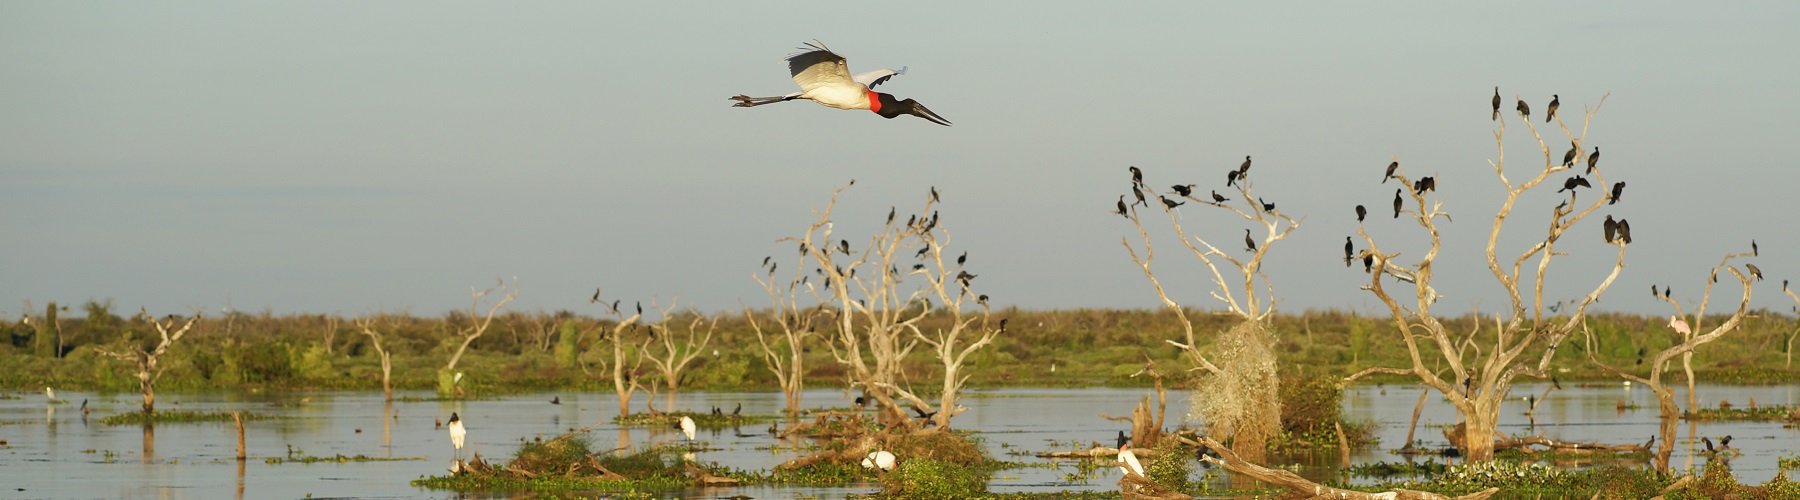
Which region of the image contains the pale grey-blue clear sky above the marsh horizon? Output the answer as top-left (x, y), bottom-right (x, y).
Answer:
top-left (0, 2), bottom-right (1800, 317)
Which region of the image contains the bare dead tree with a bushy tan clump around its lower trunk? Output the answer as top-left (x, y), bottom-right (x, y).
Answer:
top-left (1120, 158), bottom-right (1303, 460)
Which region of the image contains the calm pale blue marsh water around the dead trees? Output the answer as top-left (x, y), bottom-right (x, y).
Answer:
top-left (0, 385), bottom-right (1800, 498)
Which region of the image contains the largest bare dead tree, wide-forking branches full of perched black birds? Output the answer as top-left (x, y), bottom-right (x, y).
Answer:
top-left (1346, 97), bottom-right (1625, 460)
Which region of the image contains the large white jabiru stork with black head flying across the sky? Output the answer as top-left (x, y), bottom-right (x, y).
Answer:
top-left (731, 40), bottom-right (950, 126)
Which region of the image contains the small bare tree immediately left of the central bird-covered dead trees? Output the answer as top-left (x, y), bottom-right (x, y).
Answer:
top-left (743, 254), bottom-right (824, 417)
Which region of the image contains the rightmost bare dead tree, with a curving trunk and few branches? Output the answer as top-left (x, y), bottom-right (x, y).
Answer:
top-left (1582, 252), bottom-right (1756, 473)
